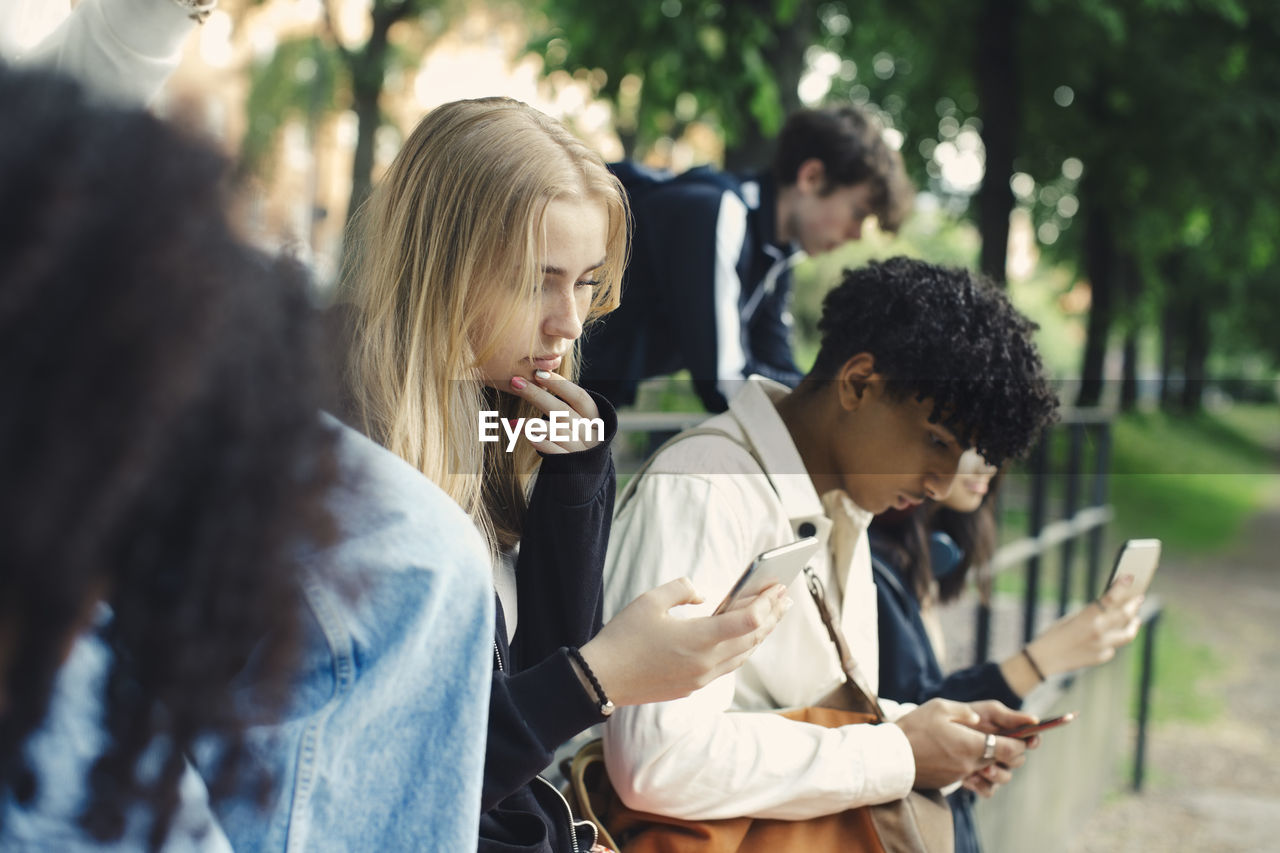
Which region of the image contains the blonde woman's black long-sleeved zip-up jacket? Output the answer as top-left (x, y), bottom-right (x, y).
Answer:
top-left (480, 394), bottom-right (617, 853)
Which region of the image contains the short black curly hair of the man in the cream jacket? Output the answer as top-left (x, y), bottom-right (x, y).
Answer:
top-left (809, 257), bottom-right (1057, 466)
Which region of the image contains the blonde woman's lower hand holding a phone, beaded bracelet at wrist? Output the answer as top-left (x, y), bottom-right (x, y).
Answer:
top-left (581, 578), bottom-right (791, 707)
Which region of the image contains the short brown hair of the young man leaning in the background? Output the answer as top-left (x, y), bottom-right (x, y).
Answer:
top-left (773, 106), bottom-right (915, 231)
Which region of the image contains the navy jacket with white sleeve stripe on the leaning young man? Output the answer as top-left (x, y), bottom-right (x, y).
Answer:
top-left (581, 163), bottom-right (800, 412)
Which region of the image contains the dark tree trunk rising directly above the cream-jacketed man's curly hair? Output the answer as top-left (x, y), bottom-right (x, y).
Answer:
top-left (975, 0), bottom-right (1021, 286)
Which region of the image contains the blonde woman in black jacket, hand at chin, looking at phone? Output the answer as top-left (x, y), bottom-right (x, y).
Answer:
top-left (347, 99), bottom-right (790, 852)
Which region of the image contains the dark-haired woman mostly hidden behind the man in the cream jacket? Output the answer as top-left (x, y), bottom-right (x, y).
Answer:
top-left (870, 450), bottom-right (1142, 853)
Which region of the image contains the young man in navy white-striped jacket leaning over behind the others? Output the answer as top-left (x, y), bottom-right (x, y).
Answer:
top-left (581, 106), bottom-right (911, 411)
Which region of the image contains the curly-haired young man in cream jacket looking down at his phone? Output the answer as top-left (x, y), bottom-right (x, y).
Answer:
top-left (604, 257), bottom-right (1057, 850)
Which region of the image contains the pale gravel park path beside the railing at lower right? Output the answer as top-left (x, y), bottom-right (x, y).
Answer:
top-left (1068, 491), bottom-right (1280, 853)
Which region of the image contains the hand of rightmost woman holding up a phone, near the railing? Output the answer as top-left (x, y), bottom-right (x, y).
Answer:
top-left (1006, 578), bottom-right (1142, 690)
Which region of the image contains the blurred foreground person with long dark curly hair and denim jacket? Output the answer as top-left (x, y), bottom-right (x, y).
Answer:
top-left (0, 67), bottom-right (493, 850)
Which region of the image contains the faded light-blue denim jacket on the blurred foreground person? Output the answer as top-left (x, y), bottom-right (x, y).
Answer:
top-left (0, 421), bottom-right (494, 853)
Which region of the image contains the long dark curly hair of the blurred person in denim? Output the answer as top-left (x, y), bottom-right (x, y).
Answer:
top-left (0, 68), bottom-right (337, 848)
